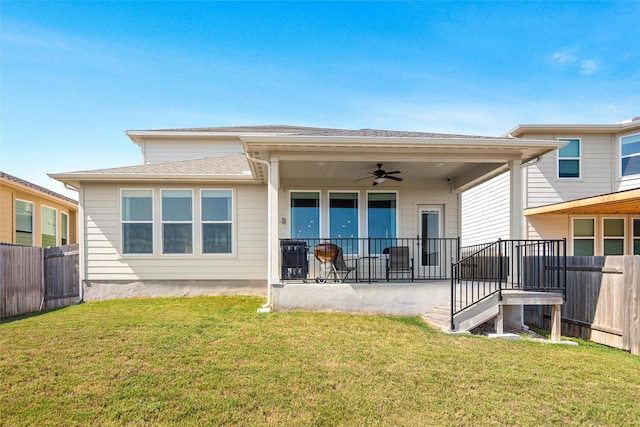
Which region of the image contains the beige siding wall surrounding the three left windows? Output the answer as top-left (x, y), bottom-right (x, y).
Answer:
top-left (83, 184), bottom-right (267, 281)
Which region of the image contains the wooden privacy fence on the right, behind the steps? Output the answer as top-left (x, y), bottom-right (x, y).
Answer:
top-left (525, 255), bottom-right (640, 355)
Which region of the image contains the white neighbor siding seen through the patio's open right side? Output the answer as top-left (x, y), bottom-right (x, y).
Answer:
top-left (461, 173), bottom-right (510, 246)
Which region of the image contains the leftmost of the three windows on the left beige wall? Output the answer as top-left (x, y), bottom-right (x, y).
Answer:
top-left (122, 190), bottom-right (153, 254)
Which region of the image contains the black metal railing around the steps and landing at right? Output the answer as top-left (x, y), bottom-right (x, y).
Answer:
top-left (451, 240), bottom-right (567, 330)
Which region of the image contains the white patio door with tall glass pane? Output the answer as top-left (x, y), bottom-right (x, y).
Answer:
top-left (417, 205), bottom-right (444, 278)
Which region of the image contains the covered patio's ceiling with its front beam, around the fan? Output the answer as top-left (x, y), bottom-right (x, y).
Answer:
top-left (241, 136), bottom-right (564, 192)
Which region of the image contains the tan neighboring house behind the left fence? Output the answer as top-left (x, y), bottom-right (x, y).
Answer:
top-left (0, 172), bottom-right (78, 247)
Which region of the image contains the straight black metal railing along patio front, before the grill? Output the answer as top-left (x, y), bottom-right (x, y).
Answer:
top-left (280, 237), bottom-right (460, 283)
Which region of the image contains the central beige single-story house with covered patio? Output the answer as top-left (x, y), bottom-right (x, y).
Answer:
top-left (50, 126), bottom-right (564, 310)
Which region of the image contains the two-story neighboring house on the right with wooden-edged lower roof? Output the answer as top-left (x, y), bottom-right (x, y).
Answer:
top-left (462, 117), bottom-right (640, 256)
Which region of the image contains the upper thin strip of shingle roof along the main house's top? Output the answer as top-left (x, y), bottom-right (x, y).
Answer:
top-left (140, 125), bottom-right (492, 138)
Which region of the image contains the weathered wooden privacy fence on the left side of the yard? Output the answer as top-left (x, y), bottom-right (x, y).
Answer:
top-left (0, 244), bottom-right (80, 318)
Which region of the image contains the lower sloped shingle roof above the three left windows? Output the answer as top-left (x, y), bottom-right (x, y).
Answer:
top-left (55, 154), bottom-right (251, 176)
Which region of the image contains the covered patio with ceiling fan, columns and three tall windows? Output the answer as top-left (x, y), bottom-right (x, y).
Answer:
top-left (241, 128), bottom-right (564, 300)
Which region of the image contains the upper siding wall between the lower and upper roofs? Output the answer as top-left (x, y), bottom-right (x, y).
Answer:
top-left (141, 139), bottom-right (244, 164)
